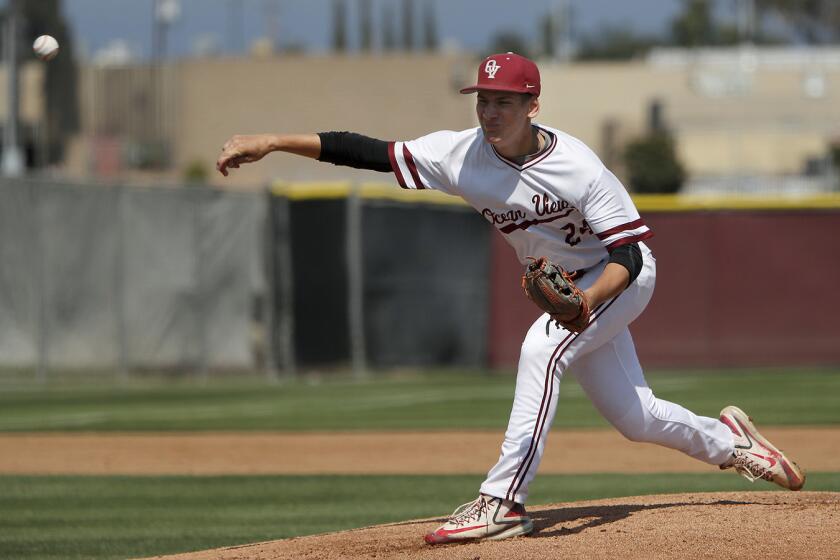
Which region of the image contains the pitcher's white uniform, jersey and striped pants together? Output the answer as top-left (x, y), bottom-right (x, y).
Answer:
top-left (388, 125), bottom-right (733, 504)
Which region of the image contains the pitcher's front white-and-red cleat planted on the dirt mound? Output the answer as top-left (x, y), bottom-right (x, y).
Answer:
top-left (425, 494), bottom-right (534, 544)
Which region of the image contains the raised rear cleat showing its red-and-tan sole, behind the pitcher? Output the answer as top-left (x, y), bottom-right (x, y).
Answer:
top-left (720, 406), bottom-right (805, 490)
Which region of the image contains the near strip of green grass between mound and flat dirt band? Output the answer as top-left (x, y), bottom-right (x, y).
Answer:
top-left (0, 472), bottom-right (840, 560)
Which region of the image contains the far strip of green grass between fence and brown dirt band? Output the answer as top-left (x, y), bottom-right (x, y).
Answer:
top-left (0, 369), bottom-right (840, 431)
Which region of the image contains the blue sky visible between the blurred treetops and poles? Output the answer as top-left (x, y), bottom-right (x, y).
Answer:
top-left (63, 0), bottom-right (696, 60)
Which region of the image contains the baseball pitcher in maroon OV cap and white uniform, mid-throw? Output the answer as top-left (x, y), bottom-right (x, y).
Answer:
top-left (216, 53), bottom-right (805, 544)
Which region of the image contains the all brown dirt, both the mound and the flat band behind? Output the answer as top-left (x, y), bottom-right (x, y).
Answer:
top-left (9, 427), bottom-right (840, 560)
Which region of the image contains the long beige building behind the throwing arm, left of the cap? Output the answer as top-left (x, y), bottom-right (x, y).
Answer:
top-left (67, 56), bottom-right (480, 187)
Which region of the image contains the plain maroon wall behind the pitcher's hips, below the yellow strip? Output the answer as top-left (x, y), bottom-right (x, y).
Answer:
top-left (489, 210), bottom-right (840, 367)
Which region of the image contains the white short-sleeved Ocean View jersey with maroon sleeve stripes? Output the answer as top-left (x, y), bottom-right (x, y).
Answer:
top-left (388, 126), bottom-right (653, 270)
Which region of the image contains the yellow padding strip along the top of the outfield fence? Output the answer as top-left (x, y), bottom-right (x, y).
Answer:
top-left (271, 181), bottom-right (840, 212)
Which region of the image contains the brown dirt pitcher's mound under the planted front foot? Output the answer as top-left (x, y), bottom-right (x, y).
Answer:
top-left (149, 492), bottom-right (840, 560)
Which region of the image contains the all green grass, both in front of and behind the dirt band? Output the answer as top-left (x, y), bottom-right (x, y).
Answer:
top-left (0, 370), bottom-right (840, 560)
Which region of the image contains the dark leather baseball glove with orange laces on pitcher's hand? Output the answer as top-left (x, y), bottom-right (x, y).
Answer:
top-left (522, 257), bottom-right (589, 333)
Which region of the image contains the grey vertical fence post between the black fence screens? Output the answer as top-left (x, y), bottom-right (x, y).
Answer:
top-left (345, 184), bottom-right (367, 378)
